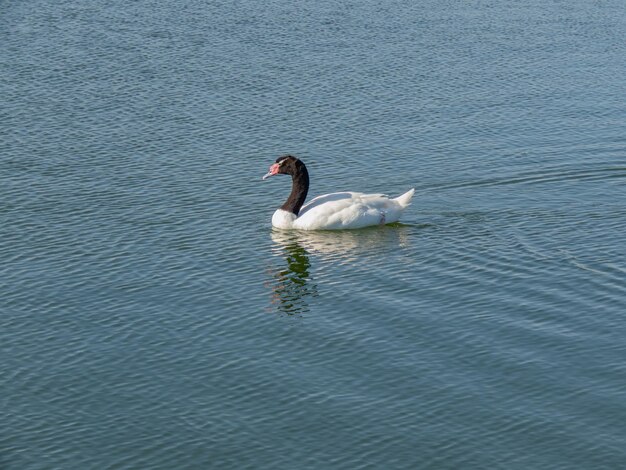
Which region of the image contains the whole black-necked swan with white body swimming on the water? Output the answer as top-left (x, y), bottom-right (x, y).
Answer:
top-left (263, 155), bottom-right (415, 230)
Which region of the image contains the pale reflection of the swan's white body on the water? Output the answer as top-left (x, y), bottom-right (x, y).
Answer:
top-left (272, 224), bottom-right (410, 261)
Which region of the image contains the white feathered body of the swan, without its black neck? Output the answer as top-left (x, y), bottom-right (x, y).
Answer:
top-left (272, 189), bottom-right (415, 230)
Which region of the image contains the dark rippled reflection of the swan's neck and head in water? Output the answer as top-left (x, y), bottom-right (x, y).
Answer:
top-left (270, 235), bottom-right (317, 315)
